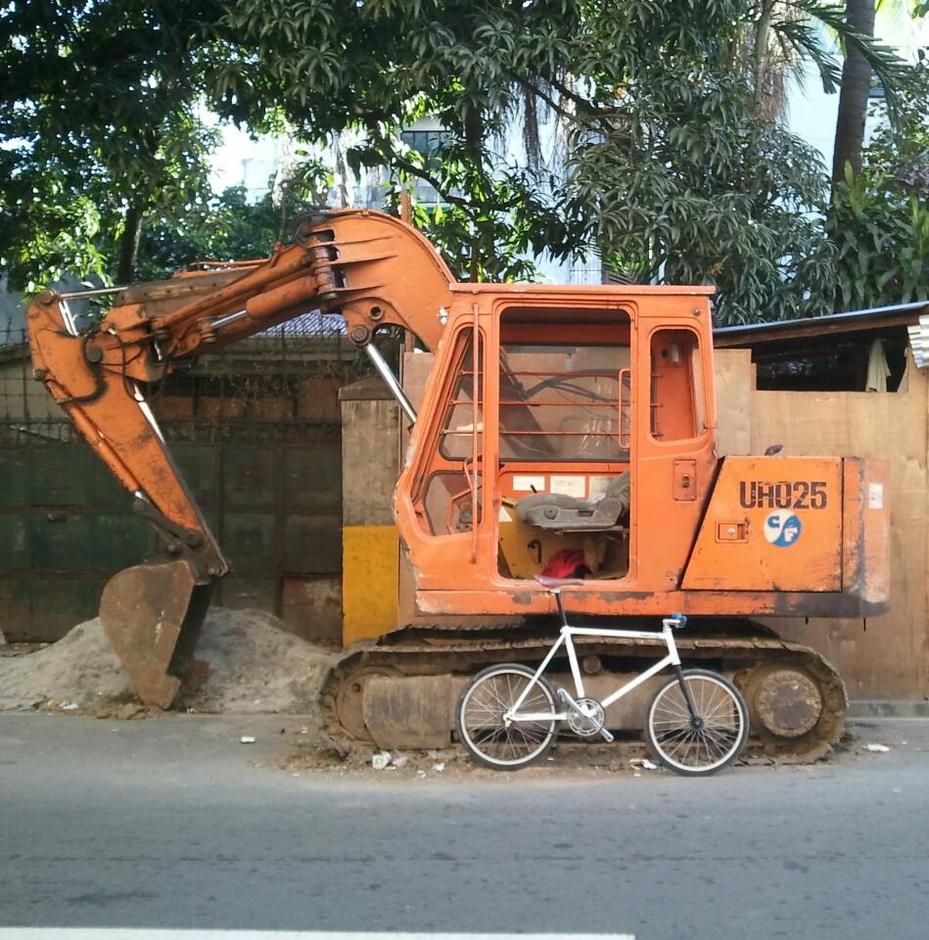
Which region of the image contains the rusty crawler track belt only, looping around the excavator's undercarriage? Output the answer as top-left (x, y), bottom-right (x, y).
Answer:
top-left (320, 630), bottom-right (848, 763)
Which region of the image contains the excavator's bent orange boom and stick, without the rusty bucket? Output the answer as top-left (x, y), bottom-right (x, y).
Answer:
top-left (28, 210), bottom-right (453, 577)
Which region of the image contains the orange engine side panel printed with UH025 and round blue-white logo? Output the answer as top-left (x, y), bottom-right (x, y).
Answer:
top-left (682, 457), bottom-right (843, 591)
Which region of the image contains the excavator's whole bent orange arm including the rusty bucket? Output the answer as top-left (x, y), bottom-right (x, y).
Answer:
top-left (28, 210), bottom-right (454, 708)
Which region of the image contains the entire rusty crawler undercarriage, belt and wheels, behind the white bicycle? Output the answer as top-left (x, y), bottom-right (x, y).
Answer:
top-left (320, 628), bottom-right (848, 762)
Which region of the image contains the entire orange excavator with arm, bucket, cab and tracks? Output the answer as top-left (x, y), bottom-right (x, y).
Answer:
top-left (28, 210), bottom-right (889, 758)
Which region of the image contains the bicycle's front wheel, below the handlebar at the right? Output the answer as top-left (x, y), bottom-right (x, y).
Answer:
top-left (645, 669), bottom-right (748, 776)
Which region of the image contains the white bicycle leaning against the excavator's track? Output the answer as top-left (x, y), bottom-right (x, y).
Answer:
top-left (455, 577), bottom-right (748, 776)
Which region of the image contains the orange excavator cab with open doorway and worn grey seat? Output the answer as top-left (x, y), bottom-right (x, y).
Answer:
top-left (397, 287), bottom-right (716, 613)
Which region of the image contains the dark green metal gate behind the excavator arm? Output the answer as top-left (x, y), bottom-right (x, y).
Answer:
top-left (0, 317), bottom-right (357, 641)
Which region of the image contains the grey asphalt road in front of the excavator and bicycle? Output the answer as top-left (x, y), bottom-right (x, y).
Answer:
top-left (0, 714), bottom-right (929, 940)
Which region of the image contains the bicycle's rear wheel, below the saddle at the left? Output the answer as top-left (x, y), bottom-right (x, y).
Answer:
top-left (455, 663), bottom-right (558, 770)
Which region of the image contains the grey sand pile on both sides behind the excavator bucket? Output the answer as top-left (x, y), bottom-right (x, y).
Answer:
top-left (0, 608), bottom-right (338, 717)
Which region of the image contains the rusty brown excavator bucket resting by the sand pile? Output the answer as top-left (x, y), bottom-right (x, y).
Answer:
top-left (100, 560), bottom-right (213, 708)
